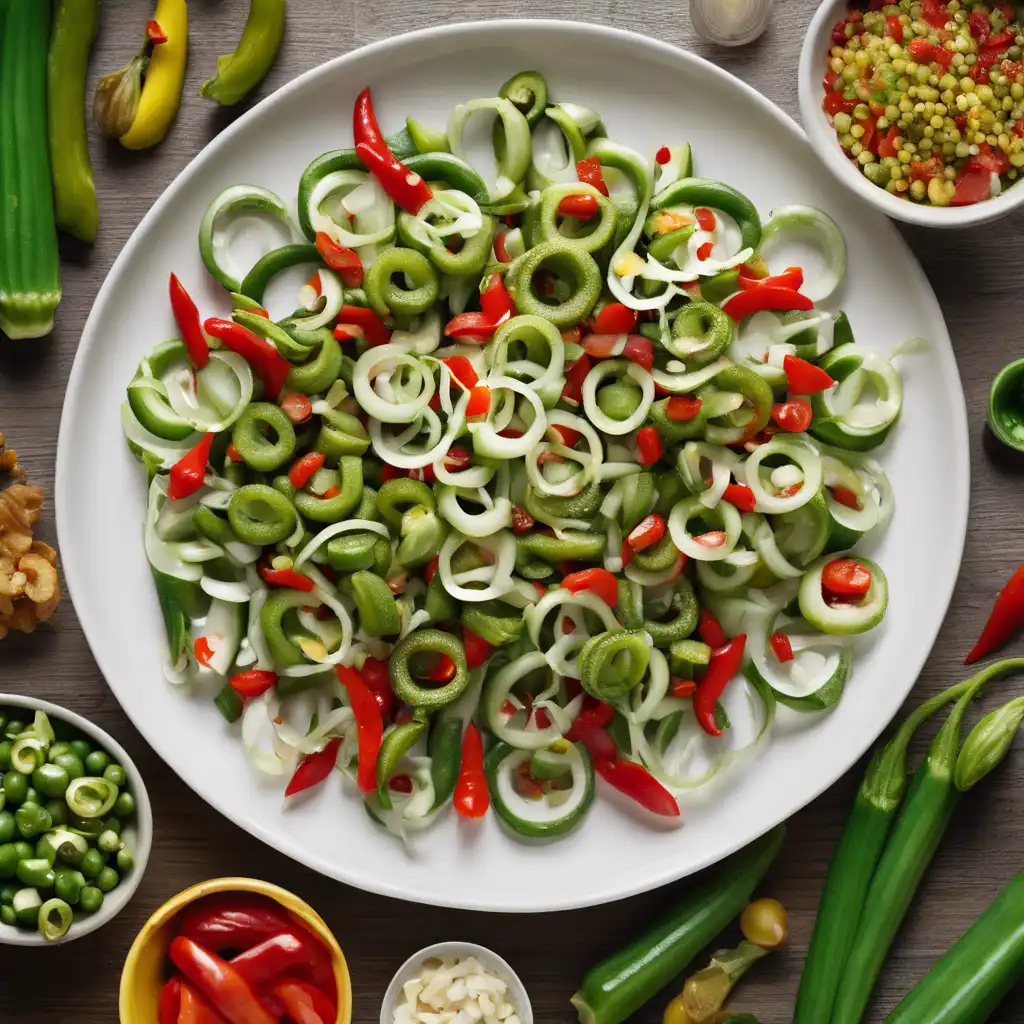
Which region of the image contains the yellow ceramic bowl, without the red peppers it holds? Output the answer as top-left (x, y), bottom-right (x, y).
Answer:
top-left (118, 879), bottom-right (352, 1024)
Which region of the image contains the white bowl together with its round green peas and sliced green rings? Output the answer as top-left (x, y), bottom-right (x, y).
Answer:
top-left (0, 693), bottom-right (153, 946)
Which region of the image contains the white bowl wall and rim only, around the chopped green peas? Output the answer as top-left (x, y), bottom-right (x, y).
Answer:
top-left (0, 693), bottom-right (153, 946)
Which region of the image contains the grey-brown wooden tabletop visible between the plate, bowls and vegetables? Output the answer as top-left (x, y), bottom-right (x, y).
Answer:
top-left (0, 0), bottom-right (1024, 1024)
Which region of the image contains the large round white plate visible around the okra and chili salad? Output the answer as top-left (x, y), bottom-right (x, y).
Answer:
top-left (56, 22), bottom-right (969, 911)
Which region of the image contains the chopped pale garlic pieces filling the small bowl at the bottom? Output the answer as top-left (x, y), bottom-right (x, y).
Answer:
top-left (394, 956), bottom-right (519, 1024)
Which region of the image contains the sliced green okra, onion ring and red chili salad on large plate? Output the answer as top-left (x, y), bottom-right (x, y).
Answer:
top-left (122, 72), bottom-right (902, 839)
